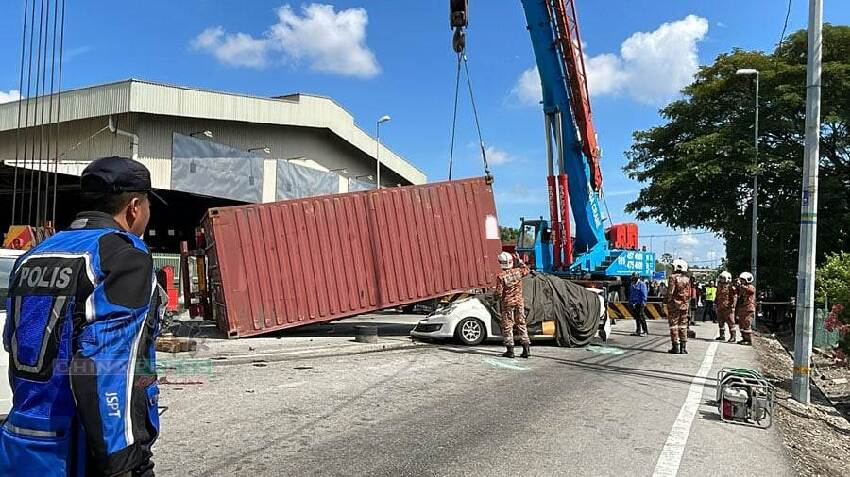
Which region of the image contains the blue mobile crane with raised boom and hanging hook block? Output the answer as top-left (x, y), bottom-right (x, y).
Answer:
top-left (450, 0), bottom-right (655, 279)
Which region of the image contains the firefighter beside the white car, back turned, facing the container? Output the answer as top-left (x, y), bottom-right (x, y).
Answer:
top-left (496, 252), bottom-right (531, 358)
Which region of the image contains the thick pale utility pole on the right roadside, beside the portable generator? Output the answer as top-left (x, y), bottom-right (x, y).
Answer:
top-left (791, 0), bottom-right (823, 404)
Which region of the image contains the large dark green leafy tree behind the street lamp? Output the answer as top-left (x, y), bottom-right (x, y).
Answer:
top-left (624, 24), bottom-right (850, 296)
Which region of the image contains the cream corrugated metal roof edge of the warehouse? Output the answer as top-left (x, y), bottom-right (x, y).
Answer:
top-left (0, 79), bottom-right (426, 184)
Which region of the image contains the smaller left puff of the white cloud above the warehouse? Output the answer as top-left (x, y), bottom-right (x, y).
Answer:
top-left (191, 26), bottom-right (269, 68)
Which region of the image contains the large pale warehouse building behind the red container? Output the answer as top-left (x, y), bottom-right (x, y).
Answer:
top-left (0, 79), bottom-right (426, 249)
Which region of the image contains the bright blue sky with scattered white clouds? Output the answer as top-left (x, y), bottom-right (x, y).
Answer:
top-left (0, 0), bottom-right (850, 261)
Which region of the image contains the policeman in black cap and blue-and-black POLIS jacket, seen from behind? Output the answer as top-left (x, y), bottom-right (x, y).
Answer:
top-left (0, 157), bottom-right (162, 477)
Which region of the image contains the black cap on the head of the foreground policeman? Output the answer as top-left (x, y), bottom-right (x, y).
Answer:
top-left (80, 156), bottom-right (167, 205)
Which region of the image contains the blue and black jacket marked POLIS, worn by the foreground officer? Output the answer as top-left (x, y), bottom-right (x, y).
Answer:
top-left (0, 224), bottom-right (159, 477)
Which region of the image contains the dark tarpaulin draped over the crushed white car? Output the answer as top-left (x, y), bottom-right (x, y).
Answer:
top-left (522, 272), bottom-right (602, 347)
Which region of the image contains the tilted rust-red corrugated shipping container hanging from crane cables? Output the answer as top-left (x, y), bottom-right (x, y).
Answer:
top-left (204, 178), bottom-right (501, 338)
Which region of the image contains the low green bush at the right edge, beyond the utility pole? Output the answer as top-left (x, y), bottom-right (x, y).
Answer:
top-left (815, 252), bottom-right (850, 360)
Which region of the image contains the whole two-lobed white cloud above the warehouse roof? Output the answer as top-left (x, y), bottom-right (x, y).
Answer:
top-left (191, 3), bottom-right (381, 78)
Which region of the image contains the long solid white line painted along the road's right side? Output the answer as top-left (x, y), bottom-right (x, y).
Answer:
top-left (652, 342), bottom-right (717, 477)
